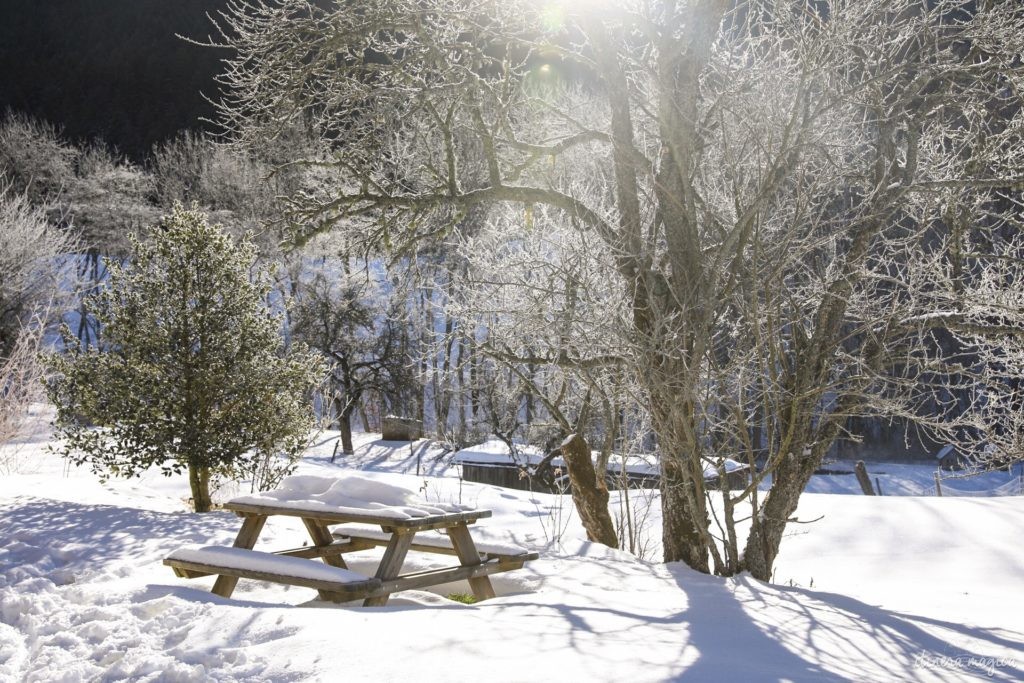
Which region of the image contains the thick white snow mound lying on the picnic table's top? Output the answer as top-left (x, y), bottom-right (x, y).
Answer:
top-left (231, 474), bottom-right (472, 519)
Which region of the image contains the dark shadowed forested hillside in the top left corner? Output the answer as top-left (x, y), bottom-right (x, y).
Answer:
top-left (0, 0), bottom-right (224, 159)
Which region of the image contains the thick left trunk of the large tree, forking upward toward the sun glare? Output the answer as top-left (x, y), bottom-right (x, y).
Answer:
top-left (593, 0), bottom-right (728, 573)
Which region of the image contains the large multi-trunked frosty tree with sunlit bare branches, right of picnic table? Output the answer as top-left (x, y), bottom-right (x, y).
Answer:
top-left (211, 0), bottom-right (1024, 580)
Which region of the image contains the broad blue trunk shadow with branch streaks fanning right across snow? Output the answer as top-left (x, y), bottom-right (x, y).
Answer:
top-left (669, 565), bottom-right (1024, 681)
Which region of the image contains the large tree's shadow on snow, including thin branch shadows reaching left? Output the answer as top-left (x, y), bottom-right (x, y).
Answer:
top-left (496, 565), bottom-right (1024, 682)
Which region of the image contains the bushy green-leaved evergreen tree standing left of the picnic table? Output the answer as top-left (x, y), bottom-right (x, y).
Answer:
top-left (47, 207), bottom-right (326, 512)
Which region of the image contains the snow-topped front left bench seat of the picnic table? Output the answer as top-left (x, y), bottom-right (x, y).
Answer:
top-left (164, 546), bottom-right (381, 599)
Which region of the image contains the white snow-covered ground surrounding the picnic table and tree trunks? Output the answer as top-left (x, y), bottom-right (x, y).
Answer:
top-left (0, 413), bottom-right (1024, 682)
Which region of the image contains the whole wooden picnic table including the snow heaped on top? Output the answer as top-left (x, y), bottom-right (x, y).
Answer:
top-left (164, 475), bottom-right (538, 605)
